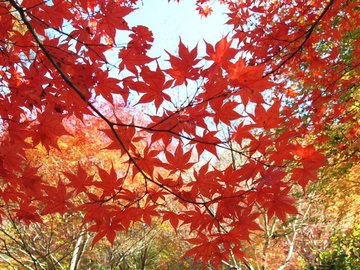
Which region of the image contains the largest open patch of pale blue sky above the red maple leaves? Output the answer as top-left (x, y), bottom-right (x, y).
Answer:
top-left (126, 0), bottom-right (229, 57)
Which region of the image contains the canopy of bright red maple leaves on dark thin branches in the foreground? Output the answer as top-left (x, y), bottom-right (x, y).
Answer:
top-left (0, 0), bottom-right (360, 267)
